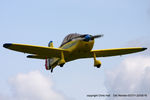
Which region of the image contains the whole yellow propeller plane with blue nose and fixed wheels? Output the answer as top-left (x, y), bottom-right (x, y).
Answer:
top-left (3, 33), bottom-right (147, 72)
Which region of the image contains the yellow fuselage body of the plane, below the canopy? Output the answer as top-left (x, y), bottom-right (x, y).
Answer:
top-left (50, 40), bottom-right (94, 66)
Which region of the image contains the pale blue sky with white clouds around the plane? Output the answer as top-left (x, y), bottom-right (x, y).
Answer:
top-left (0, 0), bottom-right (150, 100)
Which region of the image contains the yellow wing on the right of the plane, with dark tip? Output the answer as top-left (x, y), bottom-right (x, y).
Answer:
top-left (90, 47), bottom-right (147, 57)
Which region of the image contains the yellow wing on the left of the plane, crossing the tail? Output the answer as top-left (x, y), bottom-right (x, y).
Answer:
top-left (3, 43), bottom-right (69, 58)
